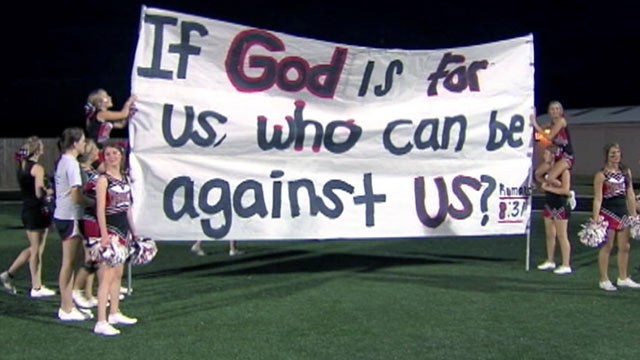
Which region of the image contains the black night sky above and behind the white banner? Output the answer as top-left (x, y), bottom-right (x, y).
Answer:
top-left (2, 0), bottom-right (640, 137)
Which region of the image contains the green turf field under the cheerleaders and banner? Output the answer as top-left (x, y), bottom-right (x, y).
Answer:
top-left (0, 204), bottom-right (640, 360)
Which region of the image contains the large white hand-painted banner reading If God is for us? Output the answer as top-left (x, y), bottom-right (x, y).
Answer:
top-left (129, 7), bottom-right (534, 240)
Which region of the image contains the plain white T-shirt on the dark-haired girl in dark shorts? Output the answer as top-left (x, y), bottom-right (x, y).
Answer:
top-left (53, 154), bottom-right (84, 220)
